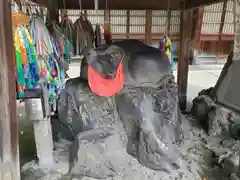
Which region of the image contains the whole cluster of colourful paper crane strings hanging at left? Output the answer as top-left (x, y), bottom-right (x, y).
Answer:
top-left (14, 16), bottom-right (69, 103)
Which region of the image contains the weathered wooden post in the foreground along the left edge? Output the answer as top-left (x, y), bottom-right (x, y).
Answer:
top-left (0, 0), bottom-right (20, 180)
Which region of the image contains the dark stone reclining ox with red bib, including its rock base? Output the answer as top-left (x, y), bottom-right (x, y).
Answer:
top-left (53, 40), bottom-right (182, 179)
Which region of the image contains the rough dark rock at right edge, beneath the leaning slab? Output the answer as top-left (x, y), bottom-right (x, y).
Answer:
top-left (192, 89), bottom-right (240, 179)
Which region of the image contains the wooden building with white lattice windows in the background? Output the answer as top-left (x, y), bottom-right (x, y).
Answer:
top-left (53, 0), bottom-right (234, 64)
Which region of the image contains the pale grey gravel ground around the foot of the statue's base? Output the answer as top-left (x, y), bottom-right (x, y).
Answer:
top-left (21, 108), bottom-right (224, 180)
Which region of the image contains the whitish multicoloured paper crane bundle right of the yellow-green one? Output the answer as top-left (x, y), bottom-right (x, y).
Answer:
top-left (31, 17), bottom-right (67, 103)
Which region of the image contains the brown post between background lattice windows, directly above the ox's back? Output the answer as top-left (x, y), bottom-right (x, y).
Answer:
top-left (145, 10), bottom-right (152, 45)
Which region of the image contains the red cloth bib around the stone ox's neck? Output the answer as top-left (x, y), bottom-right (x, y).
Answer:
top-left (88, 58), bottom-right (124, 97)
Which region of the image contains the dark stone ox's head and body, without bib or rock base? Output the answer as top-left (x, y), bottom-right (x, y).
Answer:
top-left (80, 40), bottom-right (171, 90)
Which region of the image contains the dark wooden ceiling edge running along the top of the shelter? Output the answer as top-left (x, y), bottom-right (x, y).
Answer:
top-left (32, 0), bottom-right (223, 10)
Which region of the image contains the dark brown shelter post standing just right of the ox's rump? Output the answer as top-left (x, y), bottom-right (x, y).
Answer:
top-left (177, 3), bottom-right (193, 111)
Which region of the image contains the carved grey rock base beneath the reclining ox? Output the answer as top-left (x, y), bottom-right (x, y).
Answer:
top-left (54, 76), bottom-right (182, 178)
